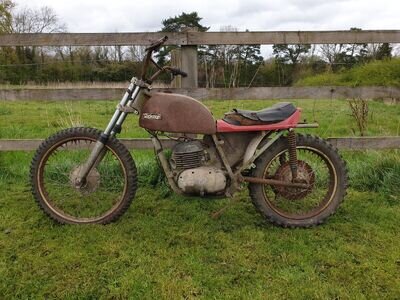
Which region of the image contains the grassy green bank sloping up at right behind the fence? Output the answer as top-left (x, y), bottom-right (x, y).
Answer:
top-left (296, 58), bottom-right (400, 87)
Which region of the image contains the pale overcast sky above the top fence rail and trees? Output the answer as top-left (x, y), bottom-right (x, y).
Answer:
top-left (11, 0), bottom-right (400, 32)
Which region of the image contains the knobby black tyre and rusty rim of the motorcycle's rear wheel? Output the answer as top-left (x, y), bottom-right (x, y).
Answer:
top-left (249, 134), bottom-right (348, 227)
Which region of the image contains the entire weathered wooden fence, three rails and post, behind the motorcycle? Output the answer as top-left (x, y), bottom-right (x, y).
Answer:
top-left (0, 30), bottom-right (400, 151)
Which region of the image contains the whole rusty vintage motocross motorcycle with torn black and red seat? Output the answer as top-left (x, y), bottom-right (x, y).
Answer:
top-left (30, 37), bottom-right (348, 227)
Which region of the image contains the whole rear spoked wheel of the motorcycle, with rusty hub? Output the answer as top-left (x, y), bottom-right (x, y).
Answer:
top-left (249, 135), bottom-right (347, 227)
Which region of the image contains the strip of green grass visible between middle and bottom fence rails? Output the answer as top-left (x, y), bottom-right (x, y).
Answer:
top-left (0, 100), bottom-right (400, 139)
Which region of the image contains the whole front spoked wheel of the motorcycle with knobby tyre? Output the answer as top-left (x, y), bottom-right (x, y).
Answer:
top-left (31, 128), bottom-right (137, 224)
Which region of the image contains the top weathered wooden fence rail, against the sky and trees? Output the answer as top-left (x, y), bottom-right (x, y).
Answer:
top-left (0, 30), bottom-right (400, 46)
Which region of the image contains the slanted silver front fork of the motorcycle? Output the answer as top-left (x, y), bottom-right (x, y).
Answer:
top-left (76, 78), bottom-right (140, 186)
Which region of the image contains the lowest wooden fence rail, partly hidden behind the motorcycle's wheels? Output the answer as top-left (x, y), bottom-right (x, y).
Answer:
top-left (0, 137), bottom-right (400, 152)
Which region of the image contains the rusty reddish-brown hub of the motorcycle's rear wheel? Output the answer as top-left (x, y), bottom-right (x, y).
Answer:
top-left (273, 160), bottom-right (315, 200)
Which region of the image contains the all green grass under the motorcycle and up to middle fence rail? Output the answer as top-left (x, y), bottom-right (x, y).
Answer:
top-left (0, 101), bottom-right (400, 299)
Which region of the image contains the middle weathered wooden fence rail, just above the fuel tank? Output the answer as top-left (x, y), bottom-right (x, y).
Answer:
top-left (0, 86), bottom-right (400, 101)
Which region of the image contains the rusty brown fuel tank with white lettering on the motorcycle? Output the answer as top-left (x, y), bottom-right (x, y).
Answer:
top-left (139, 93), bottom-right (216, 134)
